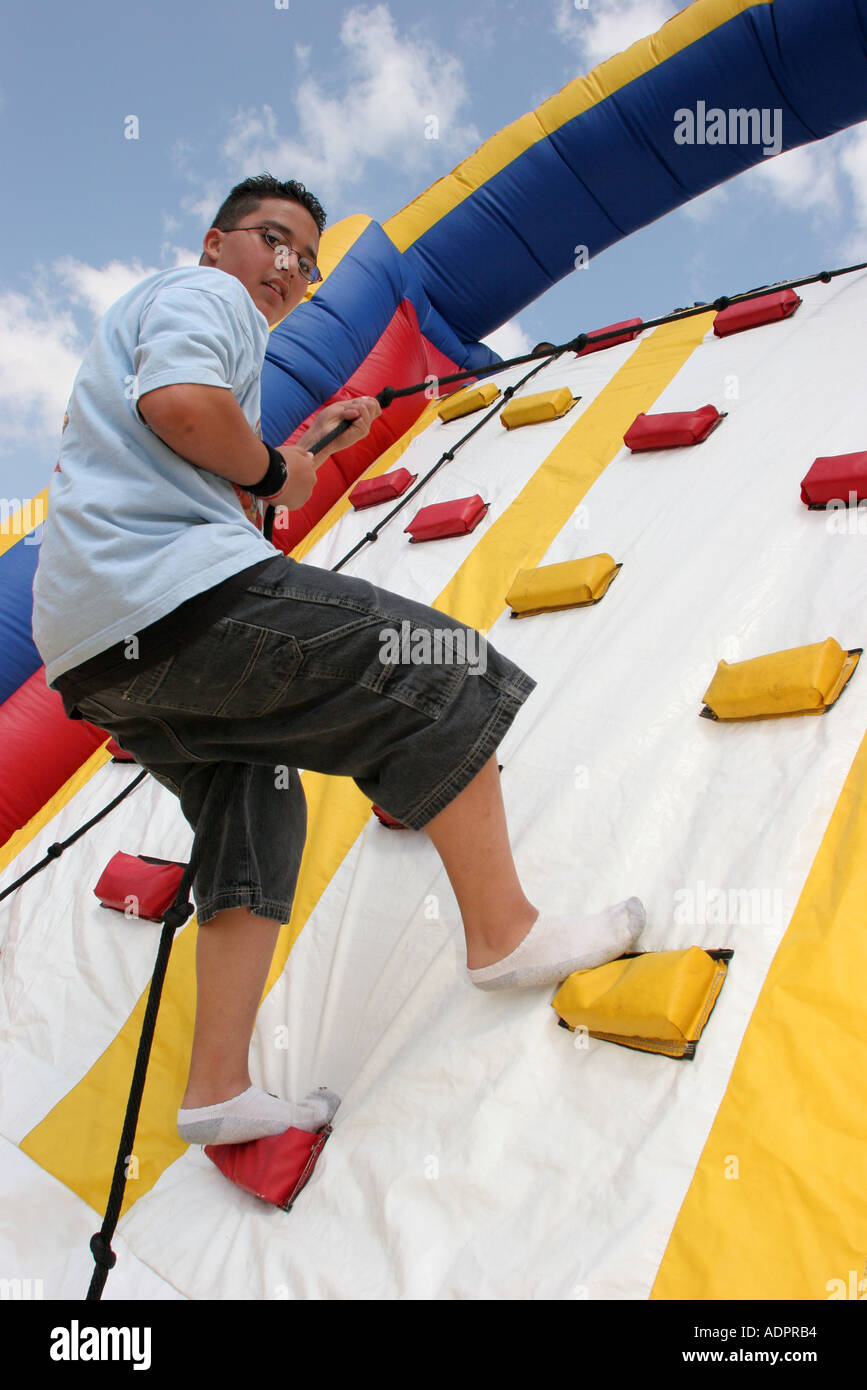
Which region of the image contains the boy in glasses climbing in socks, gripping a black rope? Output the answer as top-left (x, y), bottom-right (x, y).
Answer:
top-left (33, 174), bottom-right (645, 1144)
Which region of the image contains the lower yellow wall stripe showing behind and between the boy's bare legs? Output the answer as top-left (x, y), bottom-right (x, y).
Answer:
top-left (21, 773), bottom-right (370, 1215)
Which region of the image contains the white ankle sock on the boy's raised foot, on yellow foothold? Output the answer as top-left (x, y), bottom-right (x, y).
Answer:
top-left (467, 898), bottom-right (646, 990)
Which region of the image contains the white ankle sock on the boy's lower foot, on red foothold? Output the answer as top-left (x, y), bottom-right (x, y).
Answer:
top-left (178, 1086), bottom-right (340, 1144)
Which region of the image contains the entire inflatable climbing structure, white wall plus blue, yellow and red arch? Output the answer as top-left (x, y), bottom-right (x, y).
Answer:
top-left (0, 0), bottom-right (867, 1300)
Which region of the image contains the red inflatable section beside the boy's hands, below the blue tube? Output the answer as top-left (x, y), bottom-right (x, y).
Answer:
top-left (272, 299), bottom-right (471, 555)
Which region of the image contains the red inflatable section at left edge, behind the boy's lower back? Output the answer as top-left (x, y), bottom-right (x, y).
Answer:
top-left (0, 666), bottom-right (108, 845)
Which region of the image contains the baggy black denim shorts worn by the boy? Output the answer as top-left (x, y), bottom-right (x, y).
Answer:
top-left (78, 556), bottom-right (536, 924)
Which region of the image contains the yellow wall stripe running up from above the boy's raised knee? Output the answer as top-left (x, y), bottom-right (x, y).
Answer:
top-left (434, 311), bottom-right (714, 625)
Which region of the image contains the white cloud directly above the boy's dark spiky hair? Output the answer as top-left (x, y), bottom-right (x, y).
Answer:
top-left (215, 4), bottom-right (479, 202)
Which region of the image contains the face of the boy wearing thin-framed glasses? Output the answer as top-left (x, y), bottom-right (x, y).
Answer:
top-left (203, 197), bottom-right (320, 327)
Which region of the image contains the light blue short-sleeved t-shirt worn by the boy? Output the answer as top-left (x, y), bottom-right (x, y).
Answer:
top-left (33, 265), bottom-right (282, 685)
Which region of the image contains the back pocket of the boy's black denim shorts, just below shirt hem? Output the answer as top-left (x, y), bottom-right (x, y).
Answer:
top-left (121, 617), bottom-right (303, 719)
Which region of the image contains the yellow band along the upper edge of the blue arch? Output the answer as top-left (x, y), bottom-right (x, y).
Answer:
top-left (383, 0), bottom-right (773, 252)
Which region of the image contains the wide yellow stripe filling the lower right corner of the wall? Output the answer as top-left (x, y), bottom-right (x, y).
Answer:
top-left (650, 733), bottom-right (867, 1295)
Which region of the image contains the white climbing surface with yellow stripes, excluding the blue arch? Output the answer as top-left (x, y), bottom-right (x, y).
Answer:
top-left (1, 272), bottom-right (867, 1300)
